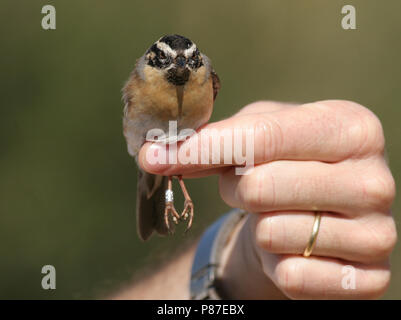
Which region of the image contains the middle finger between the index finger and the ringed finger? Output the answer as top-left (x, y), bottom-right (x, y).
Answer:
top-left (220, 159), bottom-right (395, 217)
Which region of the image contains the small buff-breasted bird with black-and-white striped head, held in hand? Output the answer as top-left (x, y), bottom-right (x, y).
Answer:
top-left (122, 34), bottom-right (220, 240)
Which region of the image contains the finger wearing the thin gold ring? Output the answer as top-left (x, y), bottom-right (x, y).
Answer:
top-left (251, 211), bottom-right (396, 263)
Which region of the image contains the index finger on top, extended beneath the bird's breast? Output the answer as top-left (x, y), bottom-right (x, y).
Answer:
top-left (139, 101), bottom-right (384, 175)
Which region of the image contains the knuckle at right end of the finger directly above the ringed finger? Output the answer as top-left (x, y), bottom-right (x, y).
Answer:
top-left (362, 170), bottom-right (396, 211)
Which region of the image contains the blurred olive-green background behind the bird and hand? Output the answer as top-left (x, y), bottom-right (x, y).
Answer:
top-left (0, 0), bottom-right (401, 299)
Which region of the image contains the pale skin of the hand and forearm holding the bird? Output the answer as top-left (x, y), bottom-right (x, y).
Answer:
top-left (117, 100), bottom-right (397, 299)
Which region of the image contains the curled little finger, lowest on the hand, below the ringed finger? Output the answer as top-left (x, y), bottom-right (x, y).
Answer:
top-left (260, 252), bottom-right (390, 299)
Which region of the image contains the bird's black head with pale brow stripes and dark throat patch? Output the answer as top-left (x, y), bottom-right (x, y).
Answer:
top-left (145, 34), bottom-right (203, 86)
